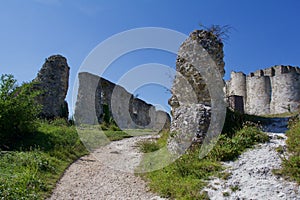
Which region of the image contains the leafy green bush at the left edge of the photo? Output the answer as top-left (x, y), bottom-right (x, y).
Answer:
top-left (0, 74), bottom-right (41, 145)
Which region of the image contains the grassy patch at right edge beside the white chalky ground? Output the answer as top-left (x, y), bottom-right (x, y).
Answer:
top-left (274, 115), bottom-right (300, 184)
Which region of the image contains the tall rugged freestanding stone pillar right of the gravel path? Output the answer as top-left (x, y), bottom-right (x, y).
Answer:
top-left (168, 30), bottom-right (225, 152)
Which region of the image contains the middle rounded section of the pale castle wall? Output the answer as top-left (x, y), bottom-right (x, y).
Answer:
top-left (246, 76), bottom-right (271, 115)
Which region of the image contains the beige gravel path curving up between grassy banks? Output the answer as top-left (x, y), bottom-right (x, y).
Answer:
top-left (50, 136), bottom-right (162, 200)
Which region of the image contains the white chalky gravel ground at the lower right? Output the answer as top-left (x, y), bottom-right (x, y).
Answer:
top-left (204, 133), bottom-right (300, 200)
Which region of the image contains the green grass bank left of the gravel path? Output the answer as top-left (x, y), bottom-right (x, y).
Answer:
top-left (0, 120), bottom-right (88, 199)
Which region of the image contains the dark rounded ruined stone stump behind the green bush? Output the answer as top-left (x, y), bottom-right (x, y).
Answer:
top-left (34, 55), bottom-right (70, 119)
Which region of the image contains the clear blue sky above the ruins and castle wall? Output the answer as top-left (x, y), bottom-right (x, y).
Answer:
top-left (0, 0), bottom-right (300, 115)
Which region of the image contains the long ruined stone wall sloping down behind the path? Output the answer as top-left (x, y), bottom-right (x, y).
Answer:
top-left (74, 72), bottom-right (170, 130)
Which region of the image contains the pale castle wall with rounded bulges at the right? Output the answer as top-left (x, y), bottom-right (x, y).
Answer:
top-left (226, 65), bottom-right (300, 115)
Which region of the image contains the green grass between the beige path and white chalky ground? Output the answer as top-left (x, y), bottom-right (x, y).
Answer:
top-left (140, 126), bottom-right (269, 199)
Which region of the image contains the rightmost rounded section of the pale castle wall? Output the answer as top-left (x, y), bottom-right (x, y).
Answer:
top-left (270, 72), bottom-right (300, 113)
